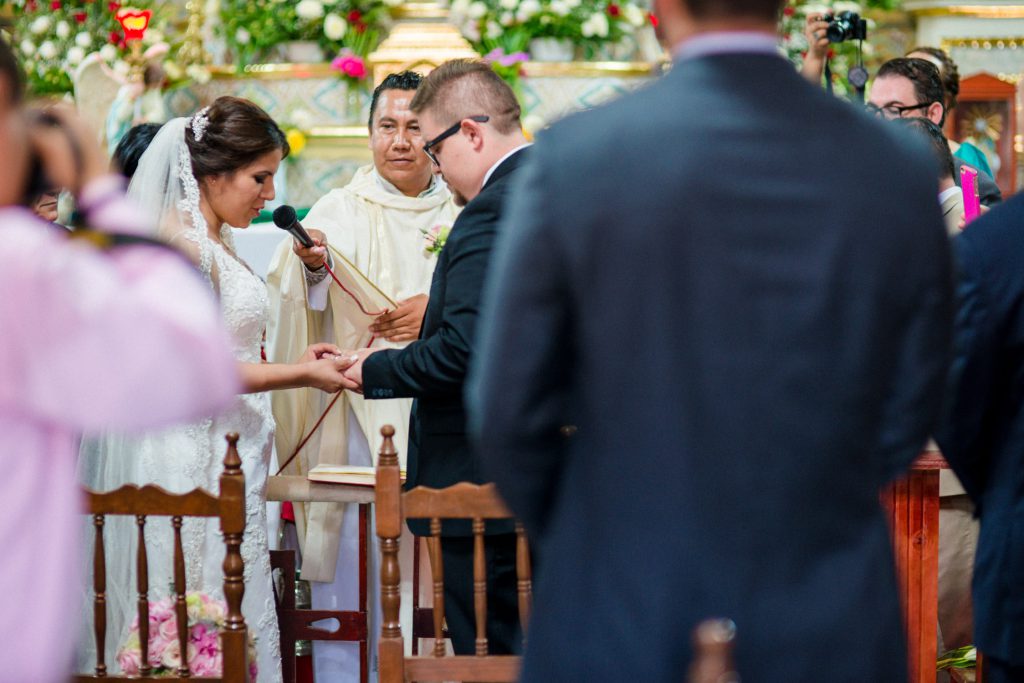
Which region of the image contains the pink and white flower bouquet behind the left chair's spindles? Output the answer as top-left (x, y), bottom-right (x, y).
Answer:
top-left (117, 592), bottom-right (256, 683)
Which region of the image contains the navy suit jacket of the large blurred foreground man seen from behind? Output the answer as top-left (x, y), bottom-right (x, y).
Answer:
top-left (468, 53), bottom-right (952, 683)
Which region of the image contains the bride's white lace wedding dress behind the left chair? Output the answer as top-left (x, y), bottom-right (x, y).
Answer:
top-left (77, 114), bottom-right (282, 683)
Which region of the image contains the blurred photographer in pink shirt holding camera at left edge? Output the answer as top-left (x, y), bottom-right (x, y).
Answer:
top-left (0, 41), bottom-right (239, 683)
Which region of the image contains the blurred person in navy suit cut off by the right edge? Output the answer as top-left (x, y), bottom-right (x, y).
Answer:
top-left (936, 195), bottom-right (1024, 683)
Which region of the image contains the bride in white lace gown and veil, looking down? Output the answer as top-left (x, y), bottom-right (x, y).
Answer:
top-left (78, 96), bottom-right (345, 683)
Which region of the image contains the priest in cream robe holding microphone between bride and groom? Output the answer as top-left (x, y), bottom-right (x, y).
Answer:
top-left (267, 72), bottom-right (458, 680)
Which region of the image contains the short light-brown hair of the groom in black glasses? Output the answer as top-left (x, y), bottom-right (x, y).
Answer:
top-left (409, 59), bottom-right (522, 135)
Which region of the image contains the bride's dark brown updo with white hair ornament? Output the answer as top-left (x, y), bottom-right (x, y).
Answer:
top-left (185, 95), bottom-right (291, 181)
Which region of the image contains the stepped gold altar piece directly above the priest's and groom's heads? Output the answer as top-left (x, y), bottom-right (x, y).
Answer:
top-left (369, 0), bottom-right (479, 85)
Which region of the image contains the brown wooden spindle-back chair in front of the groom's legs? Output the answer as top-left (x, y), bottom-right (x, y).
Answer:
top-left (377, 425), bottom-right (532, 683)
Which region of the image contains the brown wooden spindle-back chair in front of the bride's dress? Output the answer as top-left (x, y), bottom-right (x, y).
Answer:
top-left (73, 434), bottom-right (249, 683)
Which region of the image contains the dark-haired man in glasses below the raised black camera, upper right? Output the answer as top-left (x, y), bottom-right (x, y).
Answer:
top-left (866, 57), bottom-right (1002, 206)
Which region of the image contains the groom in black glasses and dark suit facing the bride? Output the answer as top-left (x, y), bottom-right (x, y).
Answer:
top-left (346, 59), bottom-right (527, 654)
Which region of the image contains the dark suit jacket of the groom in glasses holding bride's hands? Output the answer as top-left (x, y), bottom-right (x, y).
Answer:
top-left (362, 150), bottom-right (528, 536)
